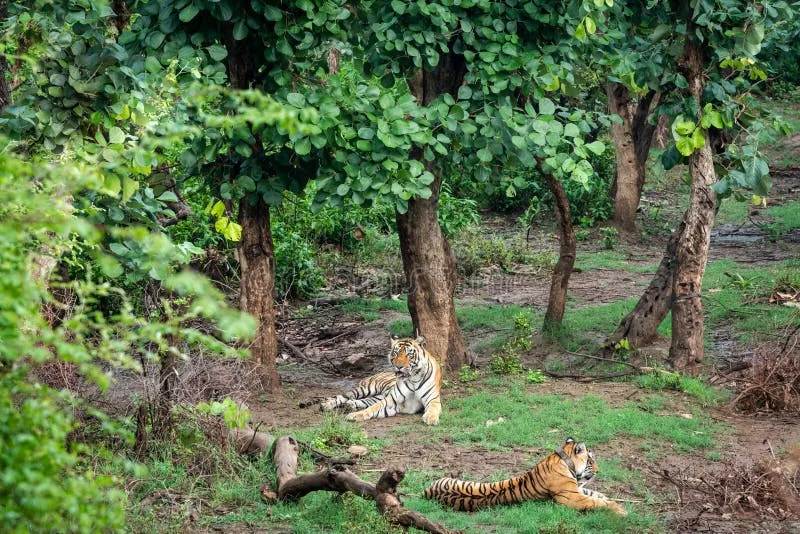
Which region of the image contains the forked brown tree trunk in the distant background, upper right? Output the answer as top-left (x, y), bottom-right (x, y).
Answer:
top-left (607, 83), bottom-right (658, 232)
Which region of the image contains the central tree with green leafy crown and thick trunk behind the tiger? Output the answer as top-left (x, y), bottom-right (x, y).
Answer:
top-left (310, 0), bottom-right (611, 370)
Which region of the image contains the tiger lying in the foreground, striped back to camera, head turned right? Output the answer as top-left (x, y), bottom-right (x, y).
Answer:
top-left (423, 438), bottom-right (628, 515)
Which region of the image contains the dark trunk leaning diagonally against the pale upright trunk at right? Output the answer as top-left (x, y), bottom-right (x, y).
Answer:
top-left (603, 220), bottom-right (685, 349)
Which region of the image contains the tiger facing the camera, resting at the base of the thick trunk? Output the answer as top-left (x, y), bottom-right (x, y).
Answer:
top-left (322, 337), bottom-right (442, 425)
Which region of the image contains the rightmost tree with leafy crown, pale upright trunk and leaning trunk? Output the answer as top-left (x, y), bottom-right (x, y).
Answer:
top-left (606, 2), bottom-right (794, 369)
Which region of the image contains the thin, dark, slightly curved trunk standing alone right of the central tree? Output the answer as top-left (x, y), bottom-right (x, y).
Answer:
top-left (540, 173), bottom-right (576, 330)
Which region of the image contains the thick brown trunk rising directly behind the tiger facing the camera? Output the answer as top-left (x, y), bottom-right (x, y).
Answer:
top-left (397, 47), bottom-right (471, 371)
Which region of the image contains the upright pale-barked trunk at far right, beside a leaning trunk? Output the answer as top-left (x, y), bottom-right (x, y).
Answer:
top-left (669, 39), bottom-right (717, 371)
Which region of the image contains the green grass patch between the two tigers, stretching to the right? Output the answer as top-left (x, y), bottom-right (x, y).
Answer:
top-left (432, 384), bottom-right (718, 451)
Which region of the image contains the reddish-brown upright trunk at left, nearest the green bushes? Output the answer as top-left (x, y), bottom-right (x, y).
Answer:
top-left (236, 197), bottom-right (280, 391)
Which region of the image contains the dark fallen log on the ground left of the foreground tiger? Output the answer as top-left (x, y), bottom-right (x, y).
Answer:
top-left (268, 436), bottom-right (456, 534)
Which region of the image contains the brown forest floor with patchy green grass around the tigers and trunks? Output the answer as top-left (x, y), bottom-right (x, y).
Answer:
top-left (128, 101), bottom-right (800, 534)
